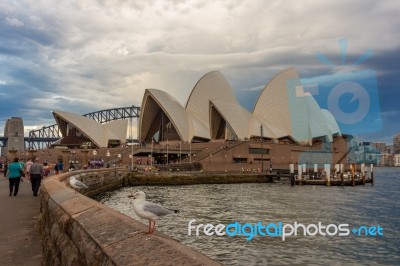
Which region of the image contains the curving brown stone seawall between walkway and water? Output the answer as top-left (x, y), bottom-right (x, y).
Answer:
top-left (40, 168), bottom-right (219, 266)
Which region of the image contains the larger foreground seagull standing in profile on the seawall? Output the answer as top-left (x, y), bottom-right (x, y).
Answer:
top-left (128, 191), bottom-right (179, 234)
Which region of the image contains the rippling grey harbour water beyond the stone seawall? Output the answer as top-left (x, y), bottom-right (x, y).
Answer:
top-left (96, 168), bottom-right (400, 265)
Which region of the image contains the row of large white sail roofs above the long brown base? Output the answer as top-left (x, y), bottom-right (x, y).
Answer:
top-left (139, 68), bottom-right (340, 144)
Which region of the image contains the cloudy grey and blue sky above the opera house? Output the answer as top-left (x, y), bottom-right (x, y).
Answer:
top-left (0, 0), bottom-right (400, 142)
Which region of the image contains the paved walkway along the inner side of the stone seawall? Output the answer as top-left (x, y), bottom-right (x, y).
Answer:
top-left (0, 174), bottom-right (42, 266)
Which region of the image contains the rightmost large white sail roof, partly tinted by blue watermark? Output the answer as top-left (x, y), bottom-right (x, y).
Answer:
top-left (253, 68), bottom-right (340, 143)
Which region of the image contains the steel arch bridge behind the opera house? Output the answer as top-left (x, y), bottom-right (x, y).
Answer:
top-left (0, 105), bottom-right (140, 150)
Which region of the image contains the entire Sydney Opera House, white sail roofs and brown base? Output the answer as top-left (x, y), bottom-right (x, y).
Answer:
top-left (49, 68), bottom-right (348, 171)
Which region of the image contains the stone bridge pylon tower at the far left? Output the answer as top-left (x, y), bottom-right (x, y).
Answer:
top-left (1, 117), bottom-right (25, 155)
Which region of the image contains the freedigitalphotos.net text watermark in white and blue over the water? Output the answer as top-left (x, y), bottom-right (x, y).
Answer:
top-left (188, 219), bottom-right (383, 241)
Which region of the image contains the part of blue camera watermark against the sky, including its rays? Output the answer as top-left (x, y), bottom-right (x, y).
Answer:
top-left (300, 40), bottom-right (382, 135)
